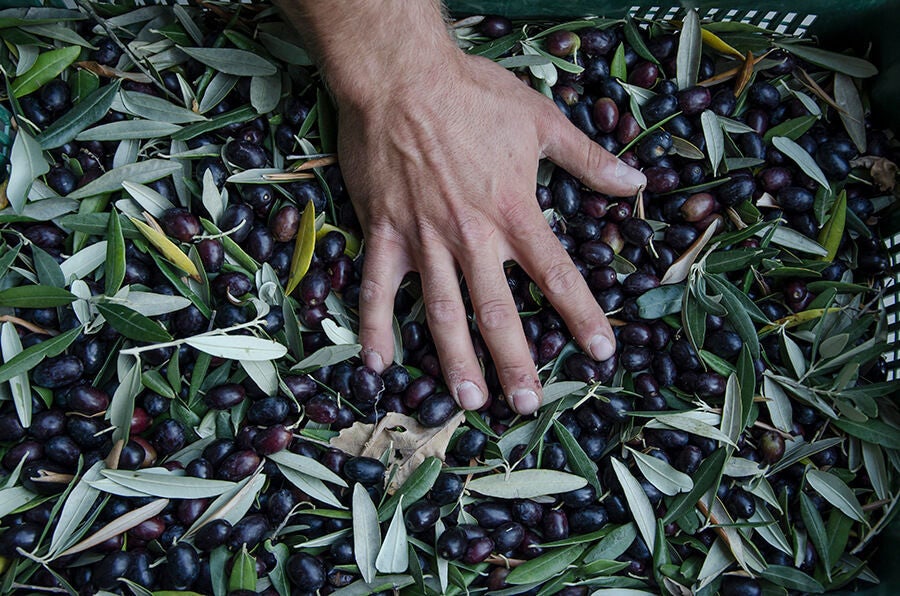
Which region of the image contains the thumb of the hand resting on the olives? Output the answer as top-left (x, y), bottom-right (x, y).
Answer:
top-left (543, 106), bottom-right (647, 197)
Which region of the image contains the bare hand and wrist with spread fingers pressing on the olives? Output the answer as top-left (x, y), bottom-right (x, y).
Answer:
top-left (278, 0), bottom-right (646, 414)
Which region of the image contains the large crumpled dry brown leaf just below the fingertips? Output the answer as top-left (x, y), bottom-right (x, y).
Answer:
top-left (329, 412), bottom-right (465, 493)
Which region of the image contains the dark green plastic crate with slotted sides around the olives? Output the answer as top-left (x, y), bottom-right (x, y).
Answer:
top-left (0, 0), bottom-right (900, 596)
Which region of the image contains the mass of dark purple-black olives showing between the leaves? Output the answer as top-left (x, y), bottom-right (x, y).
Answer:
top-left (0, 5), bottom-right (892, 596)
